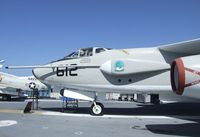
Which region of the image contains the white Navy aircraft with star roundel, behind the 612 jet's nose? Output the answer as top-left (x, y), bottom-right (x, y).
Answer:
top-left (0, 60), bottom-right (48, 101)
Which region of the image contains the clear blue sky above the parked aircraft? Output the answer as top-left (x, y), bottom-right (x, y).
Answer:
top-left (0, 0), bottom-right (200, 75)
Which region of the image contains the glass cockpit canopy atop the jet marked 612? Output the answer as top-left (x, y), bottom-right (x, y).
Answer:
top-left (64, 47), bottom-right (110, 59)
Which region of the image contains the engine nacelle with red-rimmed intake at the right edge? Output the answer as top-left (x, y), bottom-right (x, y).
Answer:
top-left (171, 55), bottom-right (200, 98)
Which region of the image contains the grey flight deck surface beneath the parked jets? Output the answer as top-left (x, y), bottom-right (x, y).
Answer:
top-left (0, 100), bottom-right (200, 137)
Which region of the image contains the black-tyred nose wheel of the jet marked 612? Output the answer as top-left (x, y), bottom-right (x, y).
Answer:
top-left (91, 102), bottom-right (104, 116)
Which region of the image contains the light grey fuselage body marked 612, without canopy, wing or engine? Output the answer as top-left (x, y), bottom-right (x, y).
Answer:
top-left (33, 48), bottom-right (172, 93)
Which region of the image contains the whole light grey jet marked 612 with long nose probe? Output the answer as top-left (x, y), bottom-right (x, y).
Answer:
top-left (8, 39), bottom-right (200, 115)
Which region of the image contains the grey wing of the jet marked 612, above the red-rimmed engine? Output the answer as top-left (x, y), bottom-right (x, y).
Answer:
top-left (158, 38), bottom-right (200, 57)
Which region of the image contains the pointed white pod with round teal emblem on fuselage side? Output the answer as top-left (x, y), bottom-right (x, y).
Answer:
top-left (100, 59), bottom-right (170, 76)
